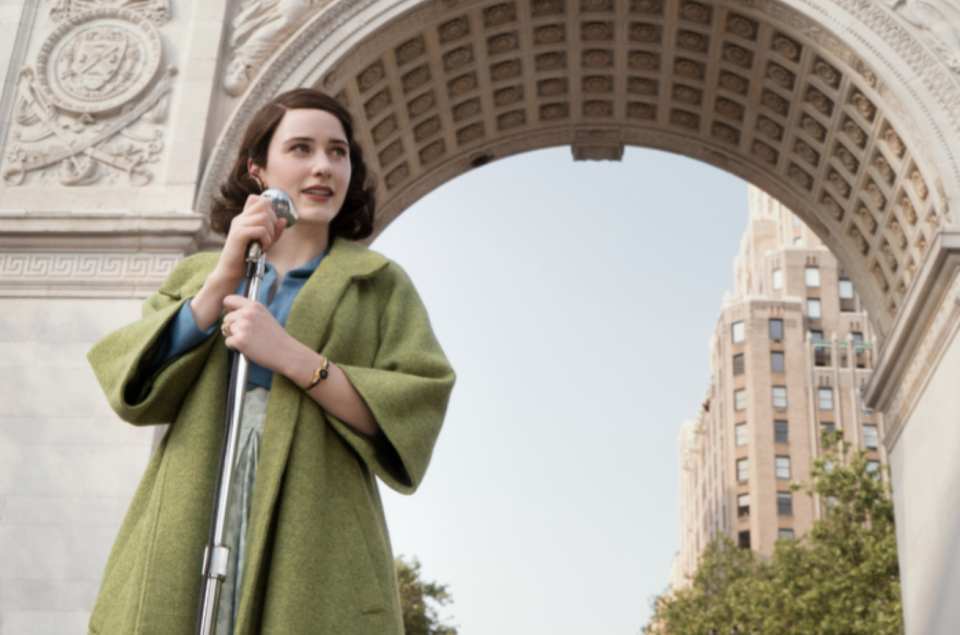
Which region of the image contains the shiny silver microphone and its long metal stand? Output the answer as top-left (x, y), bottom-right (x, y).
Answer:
top-left (196, 189), bottom-right (297, 635)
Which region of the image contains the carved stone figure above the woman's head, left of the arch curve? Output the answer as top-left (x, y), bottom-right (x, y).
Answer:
top-left (223, 0), bottom-right (328, 97)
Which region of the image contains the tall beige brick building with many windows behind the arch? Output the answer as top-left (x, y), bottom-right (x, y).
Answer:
top-left (671, 187), bottom-right (886, 588)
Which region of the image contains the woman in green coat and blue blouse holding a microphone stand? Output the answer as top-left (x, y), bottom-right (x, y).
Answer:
top-left (88, 89), bottom-right (454, 635)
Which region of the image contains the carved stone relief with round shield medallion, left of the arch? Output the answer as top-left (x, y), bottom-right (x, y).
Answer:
top-left (0, 0), bottom-right (176, 187)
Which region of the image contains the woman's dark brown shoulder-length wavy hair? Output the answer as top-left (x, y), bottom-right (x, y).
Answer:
top-left (210, 88), bottom-right (377, 240)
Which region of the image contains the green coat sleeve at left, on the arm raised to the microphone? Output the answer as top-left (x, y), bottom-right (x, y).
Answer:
top-left (87, 254), bottom-right (216, 425)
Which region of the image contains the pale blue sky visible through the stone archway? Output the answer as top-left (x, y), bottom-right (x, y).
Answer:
top-left (373, 147), bottom-right (748, 635)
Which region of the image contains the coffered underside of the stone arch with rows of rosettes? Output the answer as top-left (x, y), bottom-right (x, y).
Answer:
top-left (206, 0), bottom-right (955, 334)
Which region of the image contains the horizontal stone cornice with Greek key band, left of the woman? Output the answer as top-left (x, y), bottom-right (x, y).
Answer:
top-left (0, 212), bottom-right (206, 298)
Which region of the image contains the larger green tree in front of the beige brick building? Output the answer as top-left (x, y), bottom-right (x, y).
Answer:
top-left (643, 432), bottom-right (904, 635)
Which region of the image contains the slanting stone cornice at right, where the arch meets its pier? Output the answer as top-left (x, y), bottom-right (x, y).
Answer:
top-left (865, 230), bottom-right (960, 450)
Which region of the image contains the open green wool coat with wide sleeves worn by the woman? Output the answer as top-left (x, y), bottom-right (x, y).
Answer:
top-left (88, 239), bottom-right (454, 635)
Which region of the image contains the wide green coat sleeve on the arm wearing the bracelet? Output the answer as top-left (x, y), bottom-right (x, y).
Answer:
top-left (327, 265), bottom-right (455, 494)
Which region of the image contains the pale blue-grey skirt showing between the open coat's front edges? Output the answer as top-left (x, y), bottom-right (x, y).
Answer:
top-left (215, 387), bottom-right (270, 635)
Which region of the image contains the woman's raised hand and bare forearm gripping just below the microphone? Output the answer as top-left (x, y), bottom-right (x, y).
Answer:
top-left (190, 194), bottom-right (287, 331)
